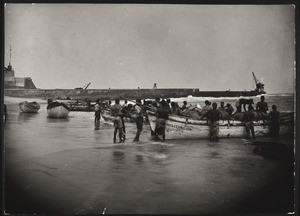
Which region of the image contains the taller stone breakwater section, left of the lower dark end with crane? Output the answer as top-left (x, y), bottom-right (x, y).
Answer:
top-left (4, 88), bottom-right (199, 100)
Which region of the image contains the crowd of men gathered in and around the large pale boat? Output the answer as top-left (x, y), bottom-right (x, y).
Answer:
top-left (95, 96), bottom-right (279, 142)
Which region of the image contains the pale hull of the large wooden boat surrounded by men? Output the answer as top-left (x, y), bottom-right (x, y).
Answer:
top-left (147, 111), bottom-right (294, 139)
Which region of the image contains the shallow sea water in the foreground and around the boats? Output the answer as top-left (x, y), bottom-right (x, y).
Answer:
top-left (4, 95), bottom-right (294, 214)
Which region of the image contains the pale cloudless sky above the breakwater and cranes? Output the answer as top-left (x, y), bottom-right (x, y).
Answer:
top-left (5, 4), bottom-right (295, 93)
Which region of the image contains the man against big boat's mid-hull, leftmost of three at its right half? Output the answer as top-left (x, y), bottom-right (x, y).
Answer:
top-left (201, 103), bottom-right (221, 139)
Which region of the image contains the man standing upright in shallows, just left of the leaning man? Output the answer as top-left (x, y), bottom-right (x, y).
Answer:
top-left (110, 99), bottom-right (124, 143)
